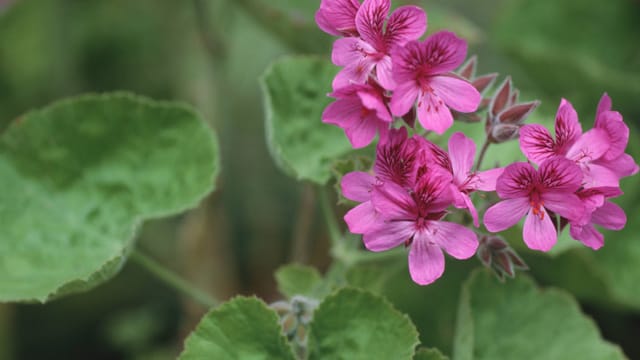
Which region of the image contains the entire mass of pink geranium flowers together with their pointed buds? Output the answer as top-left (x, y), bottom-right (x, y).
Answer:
top-left (316, 0), bottom-right (638, 285)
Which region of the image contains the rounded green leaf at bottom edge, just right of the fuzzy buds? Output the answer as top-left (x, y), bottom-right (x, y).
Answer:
top-left (309, 288), bottom-right (418, 360)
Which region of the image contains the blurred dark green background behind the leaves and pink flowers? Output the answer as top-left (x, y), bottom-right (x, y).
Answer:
top-left (0, 0), bottom-right (640, 359)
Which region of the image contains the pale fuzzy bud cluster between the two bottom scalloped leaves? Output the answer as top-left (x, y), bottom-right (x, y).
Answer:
top-left (269, 295), bottom-right (319, 359)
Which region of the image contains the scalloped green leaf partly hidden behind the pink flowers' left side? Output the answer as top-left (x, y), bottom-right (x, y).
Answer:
top-left (262, 57), bottom-right (351, 185)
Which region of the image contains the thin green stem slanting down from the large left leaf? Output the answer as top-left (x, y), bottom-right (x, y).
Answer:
top-left (130, 249), bottom-right (218, 308)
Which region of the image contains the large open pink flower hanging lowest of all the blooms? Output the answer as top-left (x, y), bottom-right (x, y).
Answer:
top-left (362, 171), bottom-right (478, 285)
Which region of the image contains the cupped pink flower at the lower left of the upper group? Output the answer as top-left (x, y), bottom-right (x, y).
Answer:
top-left (322, 83), bottom-right (393, 148)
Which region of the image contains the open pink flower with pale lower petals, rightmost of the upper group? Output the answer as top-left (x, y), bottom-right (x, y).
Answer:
top-left (391, 31), bottom-right (482, 135)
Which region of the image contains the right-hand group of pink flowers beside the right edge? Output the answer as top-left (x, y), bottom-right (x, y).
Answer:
top-left (484, 94), bottom-right (638, 251)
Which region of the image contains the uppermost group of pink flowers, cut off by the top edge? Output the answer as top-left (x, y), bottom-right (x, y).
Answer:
top-left (316, 0), bottom-right (482, 148)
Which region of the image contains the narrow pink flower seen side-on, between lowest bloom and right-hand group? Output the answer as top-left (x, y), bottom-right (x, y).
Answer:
top-left (425, 132), bottom-right (504, 227)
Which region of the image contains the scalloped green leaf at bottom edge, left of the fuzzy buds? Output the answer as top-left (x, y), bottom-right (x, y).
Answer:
top-left (179, 297), bottom-right (294, 360)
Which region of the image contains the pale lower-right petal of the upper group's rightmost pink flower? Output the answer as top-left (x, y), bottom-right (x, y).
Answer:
top-left (429, 76), bottom-right (482, 113)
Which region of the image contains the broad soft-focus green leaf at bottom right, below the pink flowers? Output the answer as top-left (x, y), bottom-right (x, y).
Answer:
top-left (453, 271), bottom-right (625, 360)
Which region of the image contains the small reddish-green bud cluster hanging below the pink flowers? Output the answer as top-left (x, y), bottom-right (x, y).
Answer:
top-left (477, 235), bottom-right (529, 281)
